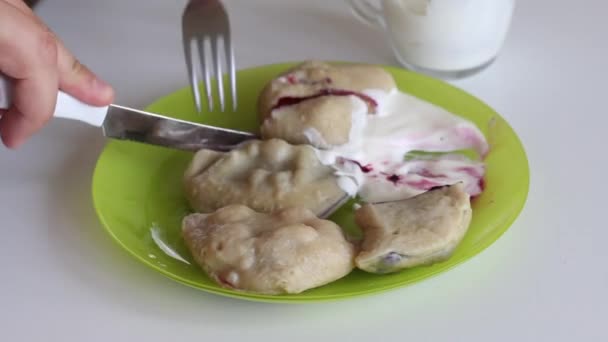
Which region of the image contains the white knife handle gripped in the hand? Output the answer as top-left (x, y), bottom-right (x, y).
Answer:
top-left (0, 74), bottom-right (108, 127)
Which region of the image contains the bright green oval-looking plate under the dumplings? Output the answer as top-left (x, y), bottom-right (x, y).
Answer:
top-left (93, 63), bottom-right (529, 302)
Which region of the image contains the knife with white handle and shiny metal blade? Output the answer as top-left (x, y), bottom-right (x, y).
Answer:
top-left (0, 74), bottom-right (258, 151)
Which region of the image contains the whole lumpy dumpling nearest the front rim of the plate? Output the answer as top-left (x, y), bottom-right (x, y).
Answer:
top-left (182, 205), bottom-right (355, 294)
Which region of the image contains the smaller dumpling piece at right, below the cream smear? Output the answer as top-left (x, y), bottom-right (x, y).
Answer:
top-left (355, 183), bottom-right (472, 273)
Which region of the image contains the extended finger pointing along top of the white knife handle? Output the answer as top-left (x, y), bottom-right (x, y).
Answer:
top-left (57, 39), bottom-right (114, 106)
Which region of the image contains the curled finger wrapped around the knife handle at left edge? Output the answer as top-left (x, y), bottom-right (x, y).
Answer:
top-left (0, 2), bottom-right (58, 147)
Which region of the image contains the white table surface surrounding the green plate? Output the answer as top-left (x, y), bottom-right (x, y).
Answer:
top-left (0, 0), bottom-right (608, 341)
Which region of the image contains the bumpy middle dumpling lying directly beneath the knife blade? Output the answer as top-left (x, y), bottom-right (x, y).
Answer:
top-left (184, 139), bottom-right (345, 216)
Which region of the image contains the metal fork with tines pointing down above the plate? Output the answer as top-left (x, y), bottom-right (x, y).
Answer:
top-left (182, 0), bottom-right (237, 113)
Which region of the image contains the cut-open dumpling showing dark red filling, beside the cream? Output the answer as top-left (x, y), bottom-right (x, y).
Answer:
top-left (259, 61), bottom-right (396, 148)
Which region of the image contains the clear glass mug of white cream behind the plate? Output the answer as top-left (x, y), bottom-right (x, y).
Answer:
top-left (349, 0), bottom-right (515, 79)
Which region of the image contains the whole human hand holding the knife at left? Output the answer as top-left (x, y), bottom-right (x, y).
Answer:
top-left (0, 0), bottom-right (114, 148)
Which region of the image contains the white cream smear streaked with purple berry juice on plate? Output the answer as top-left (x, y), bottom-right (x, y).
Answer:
top-left (312, 89), bottom-right (489, 202)
